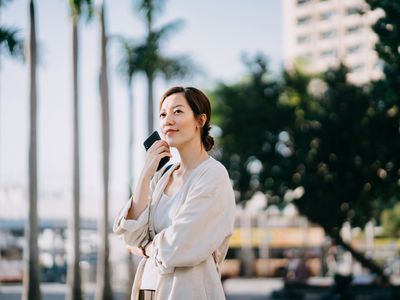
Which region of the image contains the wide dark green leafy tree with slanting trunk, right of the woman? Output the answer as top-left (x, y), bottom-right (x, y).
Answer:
top-left (213, 55), bottom-right (391, 280)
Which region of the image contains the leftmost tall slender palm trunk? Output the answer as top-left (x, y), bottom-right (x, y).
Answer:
top-left (22, 0), bottom-right (40, 300)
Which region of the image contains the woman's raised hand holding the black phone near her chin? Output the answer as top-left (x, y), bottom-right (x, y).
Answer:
top-left (142, 140), bottom-right (172, 177)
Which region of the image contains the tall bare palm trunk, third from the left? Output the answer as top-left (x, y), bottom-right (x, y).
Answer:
top-left (96, 2), bottom-right (112, 300)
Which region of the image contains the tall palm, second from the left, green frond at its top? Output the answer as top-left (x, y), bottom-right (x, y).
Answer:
top-left (67, 0), bottom-right (93, 300)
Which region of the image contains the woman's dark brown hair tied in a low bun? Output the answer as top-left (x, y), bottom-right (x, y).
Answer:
top-left (160, 86), bottom-right (214, 151)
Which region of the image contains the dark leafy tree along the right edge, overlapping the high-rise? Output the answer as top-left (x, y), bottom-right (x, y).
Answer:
top-left (367, 0), bottom-right (400, 213)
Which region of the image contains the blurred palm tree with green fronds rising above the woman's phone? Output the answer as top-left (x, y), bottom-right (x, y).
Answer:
top-left (138, 0), bottom-right (194, 133)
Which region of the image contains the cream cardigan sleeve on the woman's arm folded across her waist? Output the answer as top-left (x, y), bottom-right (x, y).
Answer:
top-left (150, 166), bottom-right (235, 274)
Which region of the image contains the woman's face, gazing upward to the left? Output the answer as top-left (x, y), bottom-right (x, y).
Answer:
top-left (160, 93), bottom-right (202, 149)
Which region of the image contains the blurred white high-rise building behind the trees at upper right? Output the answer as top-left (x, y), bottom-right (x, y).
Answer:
top-left (283, 0), bottom-right (382, 84)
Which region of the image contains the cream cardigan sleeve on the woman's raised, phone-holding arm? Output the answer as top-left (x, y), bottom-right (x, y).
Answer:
top-left (113, 168), bottom-right (162, 247)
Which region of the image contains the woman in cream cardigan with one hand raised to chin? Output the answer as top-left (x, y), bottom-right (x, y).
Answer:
top-left (114, 87), bottom-right (235, 300)
